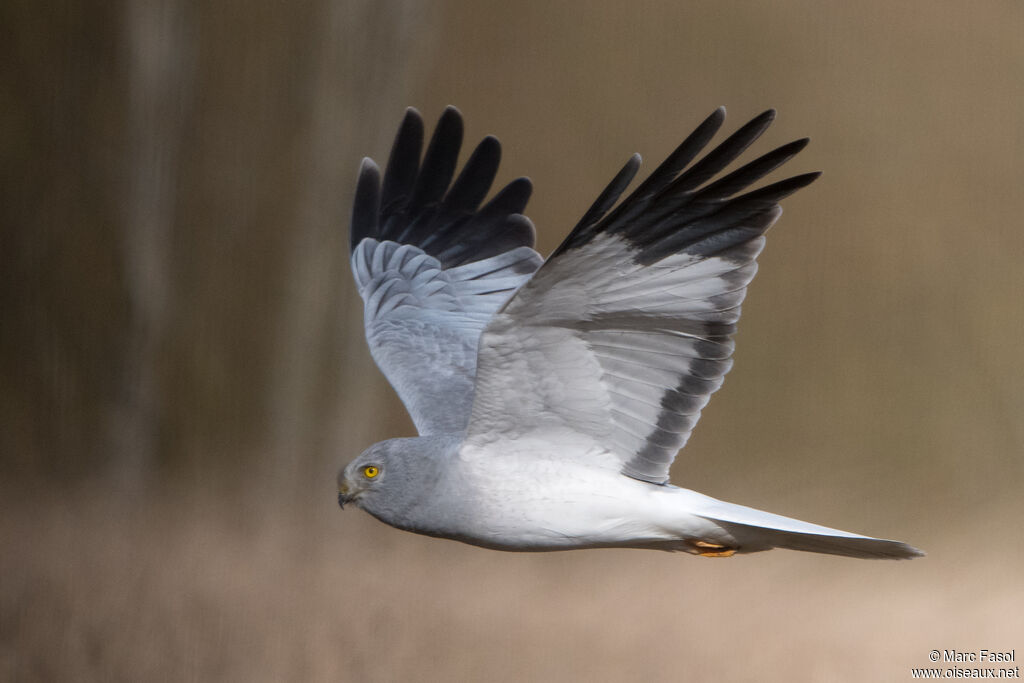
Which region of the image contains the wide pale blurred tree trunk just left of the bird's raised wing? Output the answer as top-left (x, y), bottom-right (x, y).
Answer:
top-left (268, 0), bottom-right (429, 492)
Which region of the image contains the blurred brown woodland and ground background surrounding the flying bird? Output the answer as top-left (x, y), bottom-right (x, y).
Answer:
top-left (0, 0), bottom-right (1024, 681)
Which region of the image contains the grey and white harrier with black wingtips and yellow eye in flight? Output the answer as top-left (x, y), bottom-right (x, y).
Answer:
top-left (338, 106), bottom-right (922, 558)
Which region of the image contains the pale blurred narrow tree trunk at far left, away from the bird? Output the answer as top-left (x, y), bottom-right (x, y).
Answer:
top-left (109, 0), bottom-right (197, 488)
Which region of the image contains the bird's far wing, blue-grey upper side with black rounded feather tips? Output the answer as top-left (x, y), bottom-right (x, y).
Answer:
top-left (351, 106), bottom-right (542, 434)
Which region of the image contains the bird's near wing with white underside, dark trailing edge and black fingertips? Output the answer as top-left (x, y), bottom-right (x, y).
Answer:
top-left (467, 109), bottom-right (818, 483)
